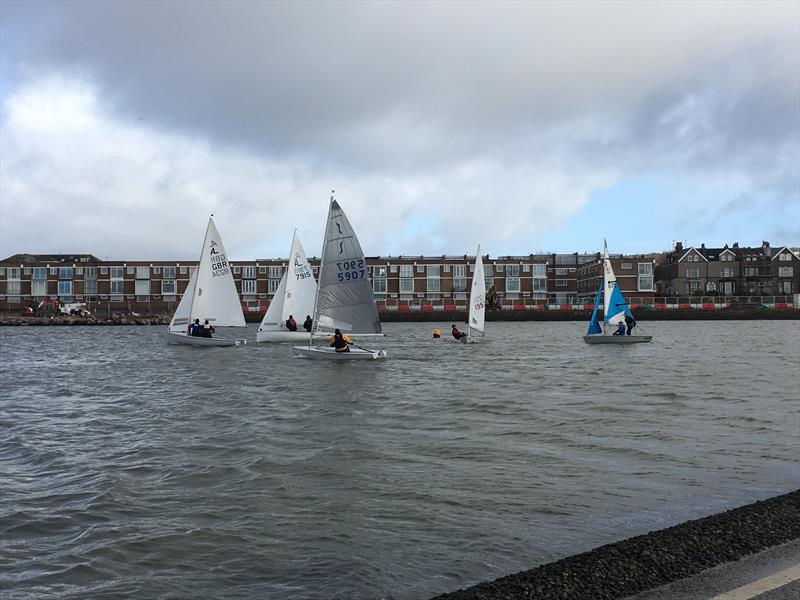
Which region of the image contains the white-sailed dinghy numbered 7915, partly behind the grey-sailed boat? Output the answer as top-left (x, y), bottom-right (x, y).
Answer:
top-left (256, 231), bottom-right (317, 343)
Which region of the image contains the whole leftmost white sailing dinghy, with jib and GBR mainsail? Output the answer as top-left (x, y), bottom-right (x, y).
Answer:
top-left (167, 219), bottom-right (247, 346)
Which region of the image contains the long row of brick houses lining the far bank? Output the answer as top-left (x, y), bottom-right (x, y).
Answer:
top-left (0, 242), bottom-right (800, 313)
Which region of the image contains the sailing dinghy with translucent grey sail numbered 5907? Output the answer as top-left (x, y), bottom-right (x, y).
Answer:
top-left (292, 196), bottom-right (386, 360)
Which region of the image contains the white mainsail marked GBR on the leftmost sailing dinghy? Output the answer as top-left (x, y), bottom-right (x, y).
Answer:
top-left (189, 219), bottom-right (247, 327)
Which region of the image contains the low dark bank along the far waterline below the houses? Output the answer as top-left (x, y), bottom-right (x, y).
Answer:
top-left (0, 308), bottom-right (800, 327)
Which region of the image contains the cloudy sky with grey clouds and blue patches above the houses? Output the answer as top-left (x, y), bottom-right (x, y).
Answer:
top-left (0, 0), bottom-right (800, 259)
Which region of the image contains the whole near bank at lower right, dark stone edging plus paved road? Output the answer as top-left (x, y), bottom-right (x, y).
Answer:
top-left (435, 490), bottom-right (800, 600)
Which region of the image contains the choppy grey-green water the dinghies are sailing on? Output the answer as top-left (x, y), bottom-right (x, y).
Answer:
top-left (0, 321), bottom-right (800, 599)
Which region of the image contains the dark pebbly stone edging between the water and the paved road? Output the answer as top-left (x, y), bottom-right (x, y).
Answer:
top-left (434, 490), bottom-right (800, 600)
